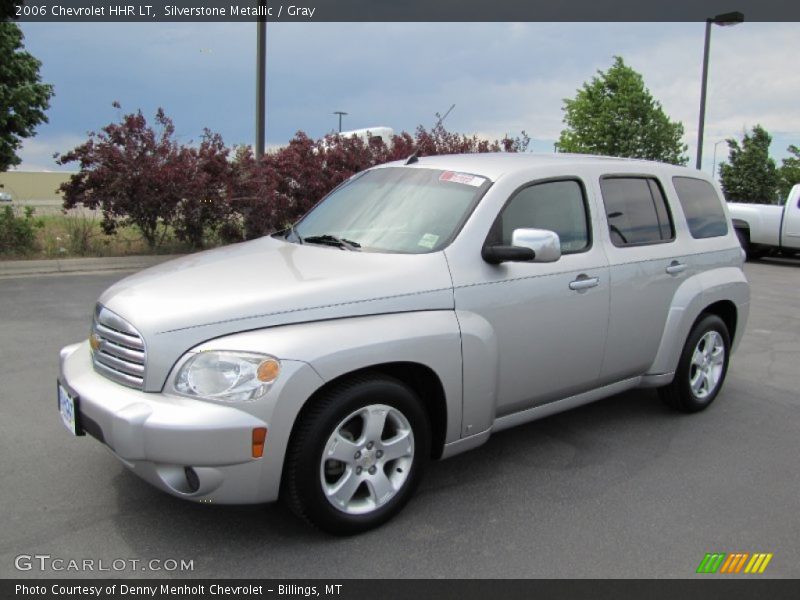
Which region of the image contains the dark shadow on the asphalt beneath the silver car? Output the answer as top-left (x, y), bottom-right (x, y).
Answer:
top-left (103, 390), bottom-right (704, 577)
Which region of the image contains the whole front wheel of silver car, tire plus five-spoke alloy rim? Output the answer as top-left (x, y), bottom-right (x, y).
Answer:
top-left (281, 374), bottom-right (431, 535)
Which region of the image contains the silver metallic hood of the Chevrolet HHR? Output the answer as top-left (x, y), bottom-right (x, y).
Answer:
top-left (100, 237), bottom-right (454, 390)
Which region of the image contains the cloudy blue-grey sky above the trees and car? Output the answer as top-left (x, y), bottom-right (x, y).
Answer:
top-left (14, 23), bottom-right (800, 178)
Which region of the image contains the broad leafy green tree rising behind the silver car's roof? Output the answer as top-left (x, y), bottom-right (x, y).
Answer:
top-left (557, 56), bottom-right (688, 165)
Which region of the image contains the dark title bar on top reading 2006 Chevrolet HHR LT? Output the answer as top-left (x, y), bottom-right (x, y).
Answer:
top-left (7, 0), bottom-right (800, 22)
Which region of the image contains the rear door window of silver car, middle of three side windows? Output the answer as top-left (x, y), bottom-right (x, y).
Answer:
top-left (600, 177), bottom-right (675, 247)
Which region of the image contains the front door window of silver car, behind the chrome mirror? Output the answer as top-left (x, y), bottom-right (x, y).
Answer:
top-left (500, 180), bottom-right (589, 254)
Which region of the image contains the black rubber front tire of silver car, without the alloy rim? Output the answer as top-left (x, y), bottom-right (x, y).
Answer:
top-left (296, 377), bottom-right (431, 535)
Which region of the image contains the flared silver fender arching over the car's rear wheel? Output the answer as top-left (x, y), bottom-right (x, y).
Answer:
top-left (647, 267), bottom-right (750, 375)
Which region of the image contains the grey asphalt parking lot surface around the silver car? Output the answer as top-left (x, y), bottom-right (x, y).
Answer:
top-left (0, 261), bottom-right (800, 578)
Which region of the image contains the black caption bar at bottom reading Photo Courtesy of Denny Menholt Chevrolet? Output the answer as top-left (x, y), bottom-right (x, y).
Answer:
top-left (0, 575), bottom-right (800, 600)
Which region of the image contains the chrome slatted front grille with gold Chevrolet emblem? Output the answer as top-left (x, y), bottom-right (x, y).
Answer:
top-left (91, 304), bottom-right (147, 389)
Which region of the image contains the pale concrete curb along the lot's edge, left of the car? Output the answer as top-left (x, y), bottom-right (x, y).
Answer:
top-left (0, 254), bottom-right (182, 278)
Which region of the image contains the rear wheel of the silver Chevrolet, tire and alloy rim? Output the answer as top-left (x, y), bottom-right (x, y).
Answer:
top-left (658, 314), bottom-right (731, 413)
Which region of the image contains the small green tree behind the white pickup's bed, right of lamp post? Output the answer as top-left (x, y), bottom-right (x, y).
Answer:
top-left (719, 125), bottom-right (778, 204)
